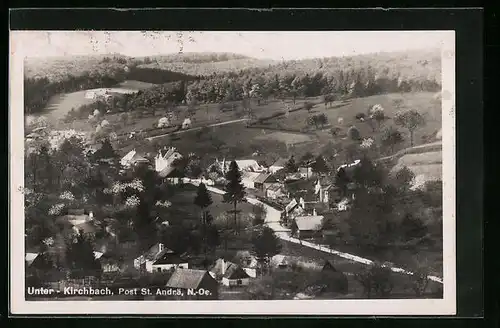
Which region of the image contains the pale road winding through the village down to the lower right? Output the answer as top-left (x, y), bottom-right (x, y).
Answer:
top-left (187, 180), bottom-right (443, 284)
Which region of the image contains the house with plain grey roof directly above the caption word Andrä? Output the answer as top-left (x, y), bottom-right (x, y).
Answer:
top-left (165, 269), bottom-right (219, 300)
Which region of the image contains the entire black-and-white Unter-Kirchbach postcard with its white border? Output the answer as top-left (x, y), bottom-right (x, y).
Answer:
top-left (9, 31), bottom-right (456, 315)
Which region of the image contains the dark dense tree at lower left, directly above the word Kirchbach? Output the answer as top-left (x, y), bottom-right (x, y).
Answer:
top-left (66, 231), bottom-right (101, 278)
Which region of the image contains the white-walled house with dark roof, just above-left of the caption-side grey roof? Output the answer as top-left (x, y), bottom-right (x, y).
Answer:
top-left (134, 243), bottom-right (189, 273)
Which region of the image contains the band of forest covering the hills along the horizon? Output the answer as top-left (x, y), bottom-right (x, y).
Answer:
top-left (25, 52), bottom-right (440, 113)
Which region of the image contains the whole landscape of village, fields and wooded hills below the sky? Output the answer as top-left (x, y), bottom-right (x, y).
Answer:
top-left (22, 43), bottom-right (443, 300)
